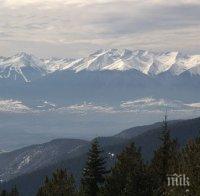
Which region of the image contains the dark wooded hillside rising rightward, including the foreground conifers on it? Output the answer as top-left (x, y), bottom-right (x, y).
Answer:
top-left (2, 119), bottom-right (200, 196)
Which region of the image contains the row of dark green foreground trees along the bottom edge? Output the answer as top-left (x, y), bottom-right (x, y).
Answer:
top-left (1, 118), bottom-right (200, 196)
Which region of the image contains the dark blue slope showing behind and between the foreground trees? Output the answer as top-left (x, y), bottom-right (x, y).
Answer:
top-left (3, 118), bottom-right (200, 195)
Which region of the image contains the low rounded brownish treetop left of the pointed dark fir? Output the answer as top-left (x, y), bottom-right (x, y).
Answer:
top-left (37, 169), bottom-right (76, 196)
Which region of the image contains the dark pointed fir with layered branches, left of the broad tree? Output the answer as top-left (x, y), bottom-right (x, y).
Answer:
top-left (80, 139), bottom-right (108, 196)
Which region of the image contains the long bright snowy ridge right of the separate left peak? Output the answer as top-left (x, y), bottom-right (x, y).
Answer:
top-left (59, 49), bottom-right (200, 75)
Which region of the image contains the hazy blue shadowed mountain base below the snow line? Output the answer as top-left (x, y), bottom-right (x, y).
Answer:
top-left (0, 70), bottom-right (200, 104)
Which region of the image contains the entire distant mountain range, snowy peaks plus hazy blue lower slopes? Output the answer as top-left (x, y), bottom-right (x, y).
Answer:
top-left (0, 49), bottom-right (200, 103)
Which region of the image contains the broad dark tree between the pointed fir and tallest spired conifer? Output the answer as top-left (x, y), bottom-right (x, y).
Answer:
top-left (101, 143), bottom-right (151, 196)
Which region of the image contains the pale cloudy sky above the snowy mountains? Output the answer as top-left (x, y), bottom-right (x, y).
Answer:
top-left (0, 0), bottom-right (200, 57)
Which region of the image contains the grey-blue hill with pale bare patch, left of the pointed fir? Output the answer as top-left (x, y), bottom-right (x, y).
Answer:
top-left (0, 139), bottom-right (88, 181)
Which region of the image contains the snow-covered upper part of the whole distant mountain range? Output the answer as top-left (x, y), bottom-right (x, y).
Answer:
top-left (0, 49), bottom-right (200, 82)
